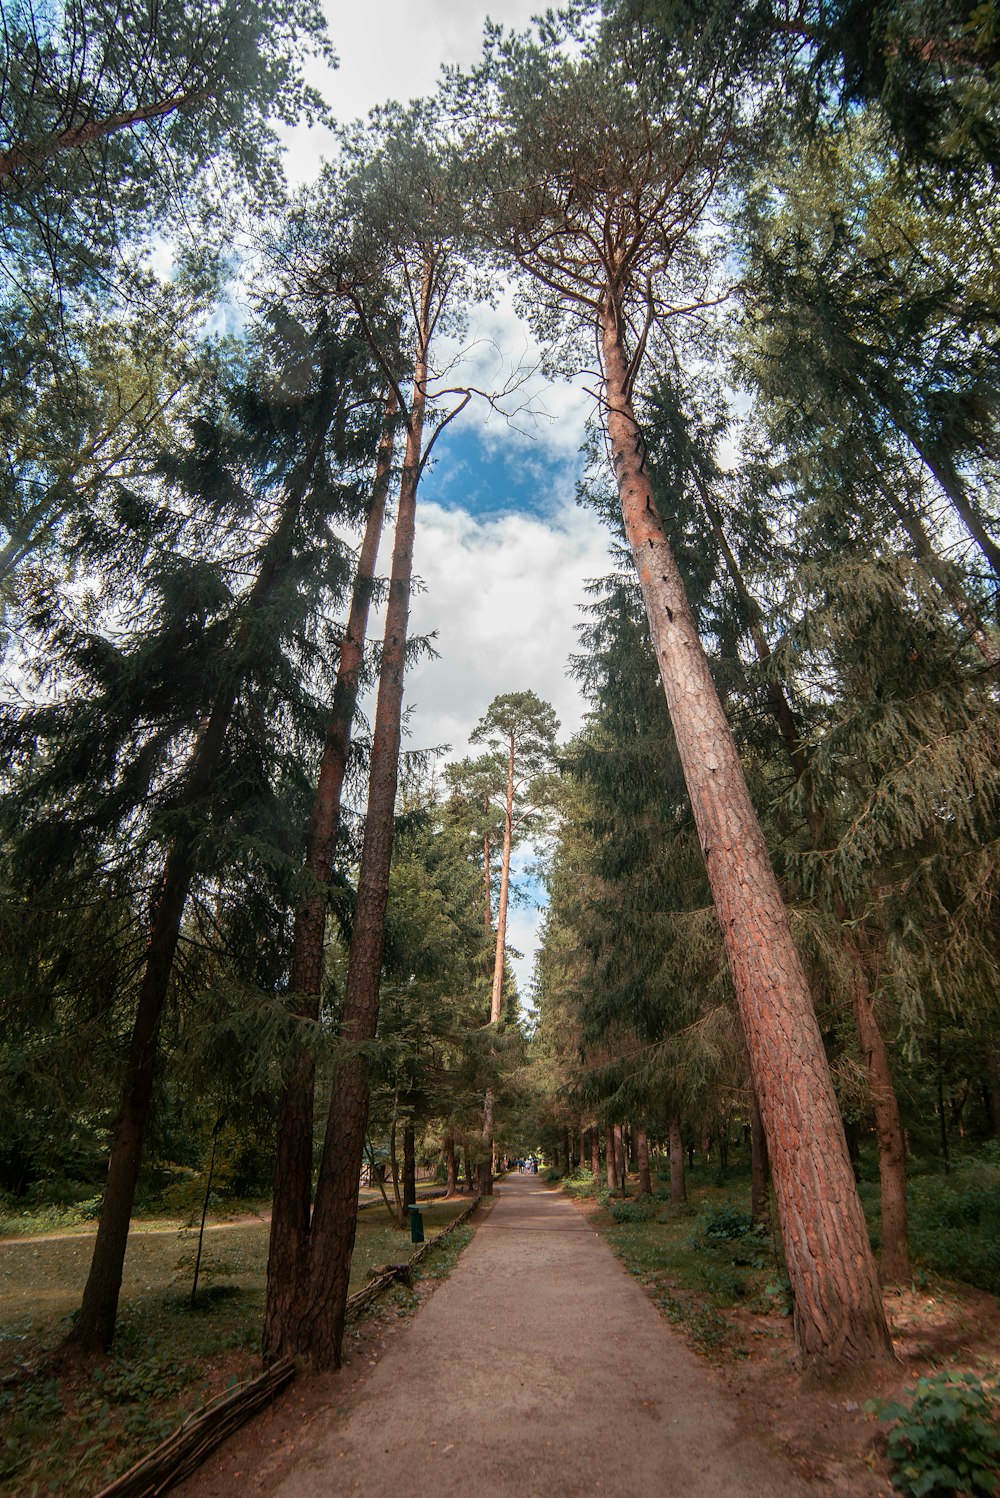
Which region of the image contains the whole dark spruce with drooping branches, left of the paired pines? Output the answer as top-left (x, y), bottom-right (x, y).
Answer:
top-left (0, 310), bottom-right (383, 1350)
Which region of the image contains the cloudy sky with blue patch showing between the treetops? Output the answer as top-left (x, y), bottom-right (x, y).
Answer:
top-left (275, 0), bottom-right (608, 995)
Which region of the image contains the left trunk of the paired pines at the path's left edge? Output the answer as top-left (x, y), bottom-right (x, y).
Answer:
top-left (263, 392), bottom-right (397, 1360)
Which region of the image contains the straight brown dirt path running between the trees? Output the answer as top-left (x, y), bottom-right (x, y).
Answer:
top-left (260, 1176), bottom-right (820, 1498)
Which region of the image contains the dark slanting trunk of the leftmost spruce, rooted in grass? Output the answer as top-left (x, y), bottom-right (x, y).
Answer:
top-left (67, 401), bottom-right (334, 1351)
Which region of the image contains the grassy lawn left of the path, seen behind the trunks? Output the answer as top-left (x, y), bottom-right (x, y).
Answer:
top-left (0, 1200), bottom-right (473, 1498)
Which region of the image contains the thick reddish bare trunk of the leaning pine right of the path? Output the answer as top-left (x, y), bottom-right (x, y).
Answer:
top-left (602, 304), bottom-right (892, 1374)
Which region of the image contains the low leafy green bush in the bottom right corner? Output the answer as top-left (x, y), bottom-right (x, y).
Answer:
top-left (865, 1372), bottom-right (1000, 1498)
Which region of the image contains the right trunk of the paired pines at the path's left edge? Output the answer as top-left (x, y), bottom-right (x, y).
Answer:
top-left (288, 347), bottom-right (430, 1368)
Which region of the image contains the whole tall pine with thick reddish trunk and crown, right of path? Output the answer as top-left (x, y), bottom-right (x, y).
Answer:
top-left (464, 8), bottom-right (892, 1372)
